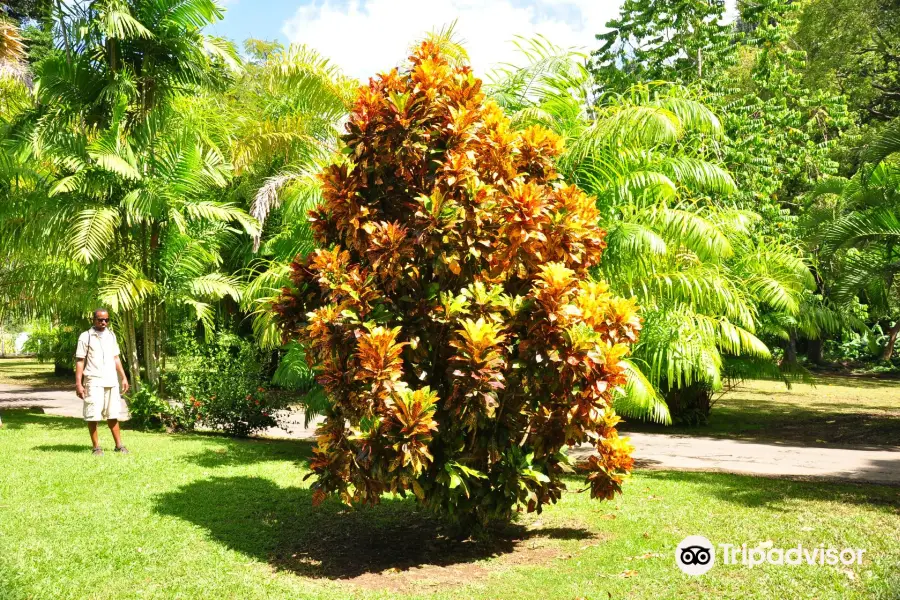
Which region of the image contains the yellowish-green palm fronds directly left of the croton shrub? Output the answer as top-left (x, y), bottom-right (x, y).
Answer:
top-left (229, 40), bottom-right (358, 352)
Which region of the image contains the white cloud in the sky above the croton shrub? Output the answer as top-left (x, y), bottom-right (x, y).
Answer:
top-left (282, 0), bottom-right (621, 80)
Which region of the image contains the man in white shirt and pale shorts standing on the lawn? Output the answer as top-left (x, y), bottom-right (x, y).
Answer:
top-left (75, 309), bottom-right (129, 456)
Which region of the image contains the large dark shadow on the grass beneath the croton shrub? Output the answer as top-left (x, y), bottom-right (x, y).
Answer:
top-left (156, 477), bottom-right (594, 579)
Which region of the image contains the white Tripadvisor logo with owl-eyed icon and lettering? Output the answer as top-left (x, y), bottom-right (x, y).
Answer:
top-left (675, 535), bottom-right (865, 575)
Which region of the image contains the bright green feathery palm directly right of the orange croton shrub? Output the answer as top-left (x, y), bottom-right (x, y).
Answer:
top-left (490, 39), bottom-right (814, 422)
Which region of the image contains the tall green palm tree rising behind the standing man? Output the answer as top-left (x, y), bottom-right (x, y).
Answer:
top-left (0, 0), bottom-right (258, 386)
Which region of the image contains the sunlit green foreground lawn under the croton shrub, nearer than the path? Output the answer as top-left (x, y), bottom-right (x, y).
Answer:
top-left (0, 411), bottom-right (900, 600)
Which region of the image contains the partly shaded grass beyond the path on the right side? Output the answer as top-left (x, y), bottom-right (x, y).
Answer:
top-left (623, 376), bottom-right (900, 447)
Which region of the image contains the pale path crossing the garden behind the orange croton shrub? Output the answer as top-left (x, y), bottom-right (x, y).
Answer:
top-left (0, 384), bottom-right (900, 486)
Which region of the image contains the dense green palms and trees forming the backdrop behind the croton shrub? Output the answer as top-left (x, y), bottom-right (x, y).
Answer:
top-left (0, 0), bottom-right (900, 438)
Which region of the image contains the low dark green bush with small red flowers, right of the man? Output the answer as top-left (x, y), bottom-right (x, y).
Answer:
top-left (166, 333), bottom-right (284, 436)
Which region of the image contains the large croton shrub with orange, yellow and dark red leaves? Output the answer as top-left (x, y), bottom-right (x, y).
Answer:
top-left (276, 42), bottom-right (640, 524)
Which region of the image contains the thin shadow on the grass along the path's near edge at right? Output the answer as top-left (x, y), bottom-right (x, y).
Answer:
top-left (641, 471), bottom-right (900, 516)
